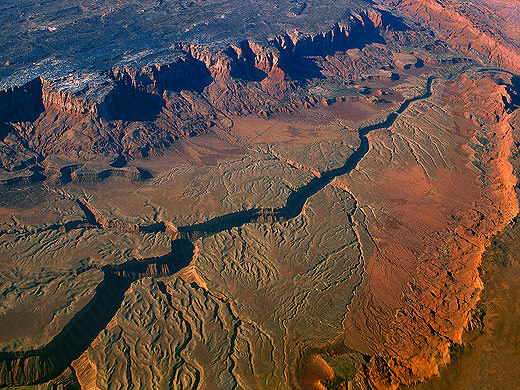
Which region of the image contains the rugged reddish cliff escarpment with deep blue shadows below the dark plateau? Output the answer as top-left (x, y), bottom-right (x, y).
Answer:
top-left (0, 11), bottom-right (391, 169)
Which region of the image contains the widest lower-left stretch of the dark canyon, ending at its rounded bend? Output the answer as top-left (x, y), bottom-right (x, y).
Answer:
top-left (0, 239), bottom-right (195, 387)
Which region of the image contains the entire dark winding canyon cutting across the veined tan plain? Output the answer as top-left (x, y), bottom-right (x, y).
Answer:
top-left (0, 77), bottom-right (434, 387)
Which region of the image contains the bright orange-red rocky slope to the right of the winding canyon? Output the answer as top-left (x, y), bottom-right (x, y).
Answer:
top-left (338, 75), bottom-right (518, 389)
